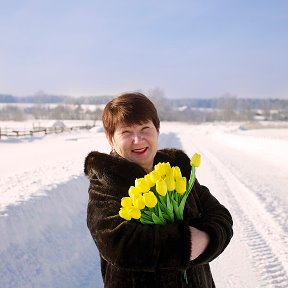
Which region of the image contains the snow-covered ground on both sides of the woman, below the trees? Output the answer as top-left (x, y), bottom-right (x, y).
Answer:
top-left (0, 122), bottom-right (288, 288)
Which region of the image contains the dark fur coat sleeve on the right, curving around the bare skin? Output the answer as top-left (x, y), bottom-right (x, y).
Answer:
top-left (189, 181), bottom-right (233, 264)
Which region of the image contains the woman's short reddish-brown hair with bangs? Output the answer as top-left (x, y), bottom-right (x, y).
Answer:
top-left (102, 92), bottom-right (160, 140)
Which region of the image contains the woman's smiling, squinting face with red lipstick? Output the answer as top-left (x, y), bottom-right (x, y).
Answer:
top-left (110, 120), bottom-right (159, 172)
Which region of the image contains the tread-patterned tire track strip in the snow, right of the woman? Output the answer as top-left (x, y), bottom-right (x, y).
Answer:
top-left (197, 146), bottom-right (288, 288)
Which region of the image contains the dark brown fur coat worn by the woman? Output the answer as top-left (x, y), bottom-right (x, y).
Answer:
top-left (84, 149), bottom-right (233, 288)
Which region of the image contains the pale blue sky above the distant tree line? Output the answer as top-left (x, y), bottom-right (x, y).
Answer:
top-left (0, 0), bottom-right (288, 99)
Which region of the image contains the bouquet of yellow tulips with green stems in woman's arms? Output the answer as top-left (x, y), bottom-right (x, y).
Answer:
top-left (119, 153), bottom-right (201, 224)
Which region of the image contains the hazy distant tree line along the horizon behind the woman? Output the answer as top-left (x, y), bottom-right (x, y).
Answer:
top-left (0, 89), bottom-right (288, 122)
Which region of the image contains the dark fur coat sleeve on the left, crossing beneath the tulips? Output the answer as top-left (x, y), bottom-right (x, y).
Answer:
top-left (87, 179), bottom-right (191, 271)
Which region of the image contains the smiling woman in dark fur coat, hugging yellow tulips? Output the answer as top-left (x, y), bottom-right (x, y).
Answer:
top-left (84, 93), bottom-right (233, 288)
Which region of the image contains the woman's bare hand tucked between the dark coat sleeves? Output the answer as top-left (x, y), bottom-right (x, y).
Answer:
top-left (189, 226), bottom-right (209, 261)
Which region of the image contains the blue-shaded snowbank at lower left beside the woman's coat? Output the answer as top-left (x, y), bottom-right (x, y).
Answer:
top-left (0, 176), bottom-right (102, 288)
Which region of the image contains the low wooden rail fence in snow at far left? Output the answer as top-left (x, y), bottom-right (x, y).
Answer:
top-left (0, 125), bottom-right (93, 139)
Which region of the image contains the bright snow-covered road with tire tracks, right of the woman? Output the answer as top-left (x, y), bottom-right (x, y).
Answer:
top-left (171, 125), bottom-right (288, 288)
